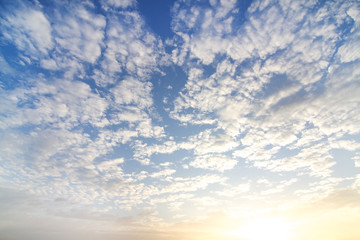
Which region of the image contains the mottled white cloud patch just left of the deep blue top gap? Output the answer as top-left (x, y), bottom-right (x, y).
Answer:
top-left (93, 11), bottom-right (165, 86)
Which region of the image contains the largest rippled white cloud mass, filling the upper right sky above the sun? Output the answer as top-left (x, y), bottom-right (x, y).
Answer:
top-left (170, 2), bottom-right (358, 180)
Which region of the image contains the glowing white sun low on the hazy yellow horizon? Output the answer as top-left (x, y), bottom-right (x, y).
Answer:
top-left (226, 217), bottom-right (292, 240)
